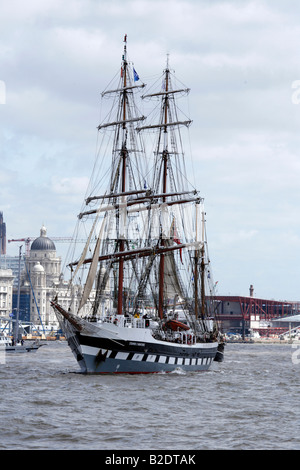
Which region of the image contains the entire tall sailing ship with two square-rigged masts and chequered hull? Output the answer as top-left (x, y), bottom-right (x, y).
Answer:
top-left (51, 36), bottom-right (223, 374)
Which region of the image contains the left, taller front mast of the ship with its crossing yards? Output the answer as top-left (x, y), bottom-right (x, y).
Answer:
top-left (95, 34), bottom-right (145, 315)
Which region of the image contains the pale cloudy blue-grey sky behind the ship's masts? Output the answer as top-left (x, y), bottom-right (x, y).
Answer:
top-left (0, 0), bottom-right (300, 301)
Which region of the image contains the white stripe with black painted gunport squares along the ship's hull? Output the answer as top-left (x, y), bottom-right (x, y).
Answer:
top-left (81, 345), bottom-right (213, 365)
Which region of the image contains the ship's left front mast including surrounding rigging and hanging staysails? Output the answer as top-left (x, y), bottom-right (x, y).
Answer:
top-left (68, 35), bottom-right (150, 317)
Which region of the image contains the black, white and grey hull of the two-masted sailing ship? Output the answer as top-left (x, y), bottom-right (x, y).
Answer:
top-left (56, 319), bottom-right (218, 374)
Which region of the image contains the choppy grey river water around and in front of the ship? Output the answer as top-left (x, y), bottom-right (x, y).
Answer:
top-left (0, 342), bottom-right (300, 450)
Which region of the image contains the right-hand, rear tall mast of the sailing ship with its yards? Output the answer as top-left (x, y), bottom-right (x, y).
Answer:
top-left (136, 57), bottom-right (193, 319)
